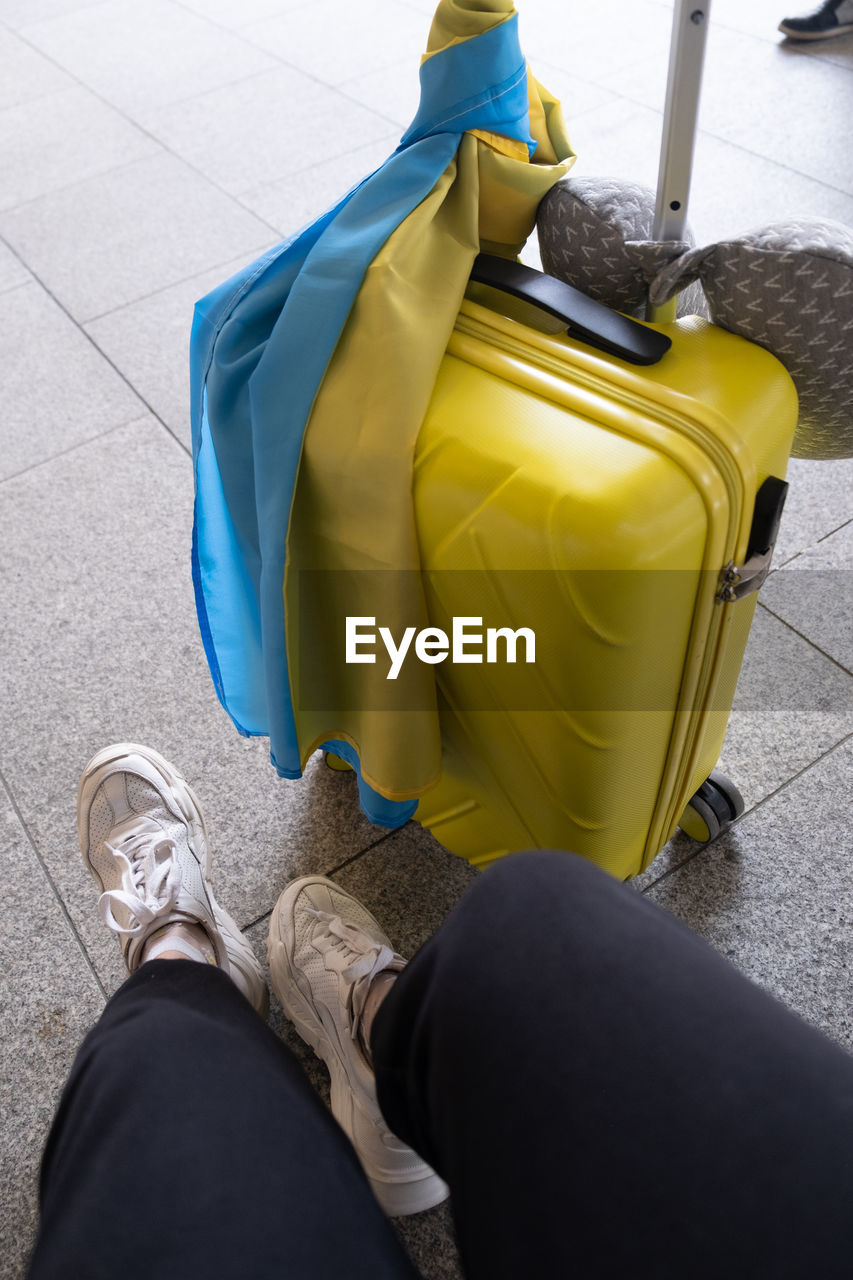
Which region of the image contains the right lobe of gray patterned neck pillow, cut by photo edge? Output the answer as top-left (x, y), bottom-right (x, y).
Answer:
top-left (651, 218), bottom-right (853, 458)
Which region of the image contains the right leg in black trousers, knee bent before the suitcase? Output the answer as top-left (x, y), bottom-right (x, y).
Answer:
top-left (371, 852), bottom-right (853, 1280)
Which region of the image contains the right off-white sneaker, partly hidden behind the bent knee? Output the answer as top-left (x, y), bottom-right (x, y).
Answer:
top-left (268, 876), bottom-right (448, 1217)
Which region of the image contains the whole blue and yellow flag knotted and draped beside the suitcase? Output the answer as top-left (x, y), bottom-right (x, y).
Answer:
top-left (191, 0), bottom-right (574, 827)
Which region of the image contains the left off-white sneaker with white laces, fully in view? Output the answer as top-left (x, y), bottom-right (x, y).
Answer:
top-left (77, 742), bottom-right (268, 1016)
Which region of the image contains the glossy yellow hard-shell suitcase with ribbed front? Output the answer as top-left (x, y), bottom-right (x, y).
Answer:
top-left (402, 264), bottom-right (797, 878)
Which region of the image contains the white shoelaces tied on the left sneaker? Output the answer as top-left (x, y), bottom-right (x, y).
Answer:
top-left (97, 832), bottom-right (181, 936)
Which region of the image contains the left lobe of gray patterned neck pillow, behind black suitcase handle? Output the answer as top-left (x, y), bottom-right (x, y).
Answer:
top-left (537, 178), bottom-right (708, 320)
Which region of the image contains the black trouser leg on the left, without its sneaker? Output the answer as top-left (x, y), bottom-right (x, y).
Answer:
top-left (29, 960), bottom-right (416, 1280)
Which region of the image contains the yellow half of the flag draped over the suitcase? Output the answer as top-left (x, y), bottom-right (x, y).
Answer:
top-left (283, 0), bottom-right (574, 800)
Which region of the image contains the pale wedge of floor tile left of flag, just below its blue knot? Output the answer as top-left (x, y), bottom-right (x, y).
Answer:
top-left (240, 131), bottom-right (400, 236)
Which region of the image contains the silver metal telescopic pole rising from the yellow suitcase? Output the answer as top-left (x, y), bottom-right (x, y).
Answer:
top-left (647, 0), bottom-right (711, 321)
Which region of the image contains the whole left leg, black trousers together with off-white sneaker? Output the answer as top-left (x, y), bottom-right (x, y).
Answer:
top-left (31, 745), bottom-right (416, 1280)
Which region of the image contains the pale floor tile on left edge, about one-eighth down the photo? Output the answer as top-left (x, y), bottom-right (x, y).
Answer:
top-left (0, 86), bottom-right (160, 209)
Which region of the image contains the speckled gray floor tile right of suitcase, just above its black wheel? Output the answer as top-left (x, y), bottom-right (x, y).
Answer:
top-left (634, 606), bottom-right (853, 888)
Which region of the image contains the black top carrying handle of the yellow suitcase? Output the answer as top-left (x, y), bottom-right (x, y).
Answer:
top-left (471, 253), bottom-right (672, 365)
